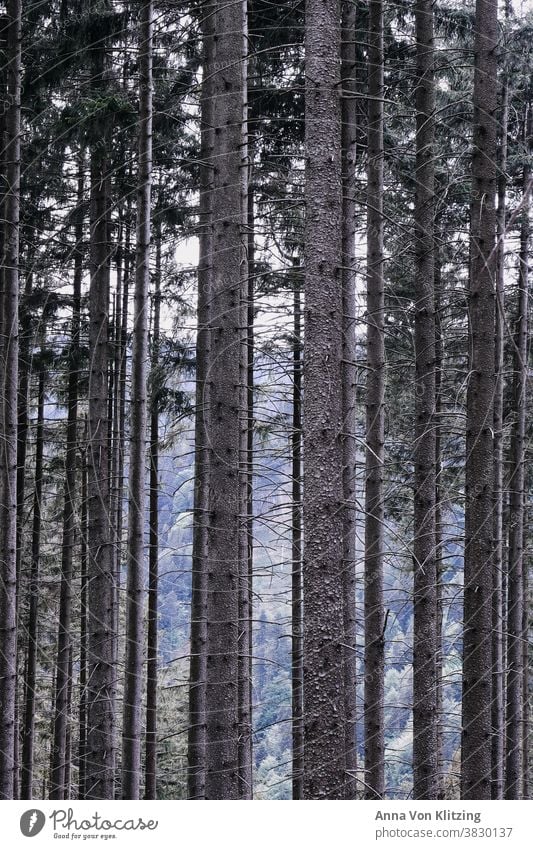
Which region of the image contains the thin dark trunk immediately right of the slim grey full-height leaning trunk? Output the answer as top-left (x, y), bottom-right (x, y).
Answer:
top-left (144, 225), bottom-right (162, 799)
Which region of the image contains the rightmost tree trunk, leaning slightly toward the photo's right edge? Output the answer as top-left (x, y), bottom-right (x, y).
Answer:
top-left (505, 104), bottom-right (531, 799)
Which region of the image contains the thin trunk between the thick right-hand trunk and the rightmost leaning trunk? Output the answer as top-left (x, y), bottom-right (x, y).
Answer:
top-left (491, 56), bottom-right (509, 799)
